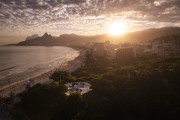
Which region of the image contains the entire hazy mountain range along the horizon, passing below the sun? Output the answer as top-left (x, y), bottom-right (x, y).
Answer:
top-left (17, 27), bottom-right (180, 48)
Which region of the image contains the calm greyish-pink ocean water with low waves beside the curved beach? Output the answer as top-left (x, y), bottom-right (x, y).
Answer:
top-left (0, 46), bottom-right (79, 87)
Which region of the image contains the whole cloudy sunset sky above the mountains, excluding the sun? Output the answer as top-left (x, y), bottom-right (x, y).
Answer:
top-left (0, 0), bottom-right (180, 44)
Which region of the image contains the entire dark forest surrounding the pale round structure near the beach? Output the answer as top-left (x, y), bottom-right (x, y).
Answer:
top-left (1, 54), bottom-right (180, 120)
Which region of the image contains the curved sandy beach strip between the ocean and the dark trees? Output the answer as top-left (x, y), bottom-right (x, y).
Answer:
top-left (0, 47), bottom-right (85, 97)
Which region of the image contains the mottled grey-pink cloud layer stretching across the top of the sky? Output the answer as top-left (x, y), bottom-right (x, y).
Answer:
top-left (0, 0), bottom-right (180, 35)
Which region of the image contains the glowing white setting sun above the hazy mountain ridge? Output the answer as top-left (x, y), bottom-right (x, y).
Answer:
top-left (108, 23), bottom-right (126, 36)
